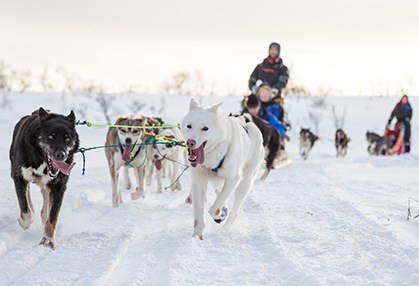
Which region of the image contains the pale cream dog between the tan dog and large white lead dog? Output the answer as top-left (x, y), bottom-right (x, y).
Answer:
top-left (147, 128), bottom-right (186, 194)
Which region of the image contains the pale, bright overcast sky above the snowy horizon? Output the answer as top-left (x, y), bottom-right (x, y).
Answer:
top-left (0, 0), bottom-right (419, 95)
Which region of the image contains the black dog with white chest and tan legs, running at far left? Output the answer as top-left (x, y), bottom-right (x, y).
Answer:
top-left (10, 108), bottom-right (79, 249)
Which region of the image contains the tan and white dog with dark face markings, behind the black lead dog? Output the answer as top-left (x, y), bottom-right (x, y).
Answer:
top-left (105, 117), bottom-right (151, 207)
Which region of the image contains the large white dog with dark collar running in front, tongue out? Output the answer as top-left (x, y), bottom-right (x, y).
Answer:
top-left (181, 99), bottom-right (265, 240)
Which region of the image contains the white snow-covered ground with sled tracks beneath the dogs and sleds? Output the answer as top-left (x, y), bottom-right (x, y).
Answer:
top-left (0, 94), bottom-right (419, 285)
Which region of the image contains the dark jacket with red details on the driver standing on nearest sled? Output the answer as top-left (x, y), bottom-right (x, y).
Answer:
top-left (249, 57), bottom-right (289, 91)
